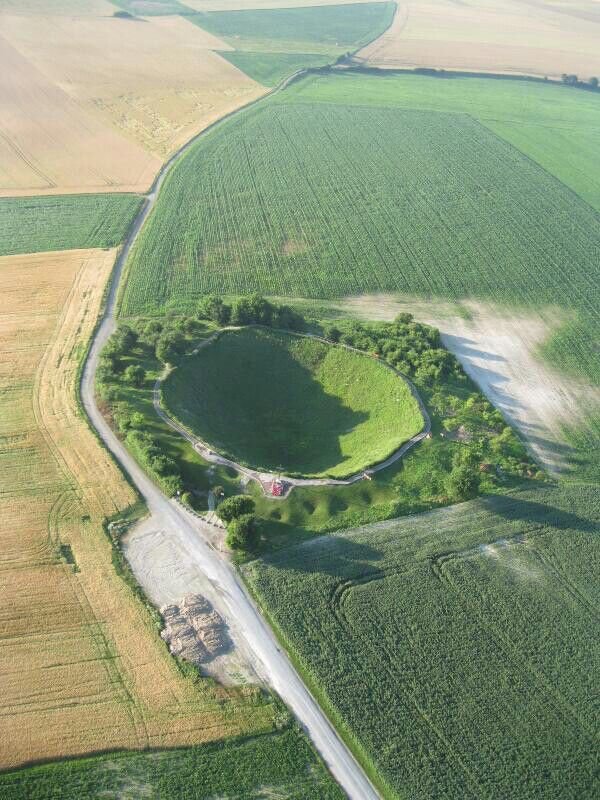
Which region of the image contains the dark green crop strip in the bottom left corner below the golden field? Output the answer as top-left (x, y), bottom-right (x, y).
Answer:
top-left (0, 727), bottom-right (343, 800)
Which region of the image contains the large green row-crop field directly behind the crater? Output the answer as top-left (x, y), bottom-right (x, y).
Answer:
top-left (121, 84), bottom-right (600, 394)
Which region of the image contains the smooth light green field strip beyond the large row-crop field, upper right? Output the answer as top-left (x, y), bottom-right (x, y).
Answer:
top-left (281, 73), bottom-right (600, 211)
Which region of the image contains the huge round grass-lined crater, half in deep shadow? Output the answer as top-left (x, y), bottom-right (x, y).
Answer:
top-left (162, 328), bottom-right (424, 478)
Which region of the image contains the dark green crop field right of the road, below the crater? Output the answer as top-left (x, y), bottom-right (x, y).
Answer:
top-left (244, 487), bottom-right (600, 800)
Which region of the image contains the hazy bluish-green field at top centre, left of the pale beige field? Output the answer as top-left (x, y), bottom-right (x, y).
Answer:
top-left (189, 2), bottom-right (396, 55)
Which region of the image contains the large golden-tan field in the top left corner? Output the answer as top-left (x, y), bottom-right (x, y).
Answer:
top-left (0, 0), bottom-right (266, 196)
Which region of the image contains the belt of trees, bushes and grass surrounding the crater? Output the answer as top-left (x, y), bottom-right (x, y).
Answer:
top-left (98, 310), bottom-right (542, 552)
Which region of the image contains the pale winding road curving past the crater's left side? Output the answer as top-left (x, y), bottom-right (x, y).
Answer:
top-left (81, 86), bottom-right (379, 800)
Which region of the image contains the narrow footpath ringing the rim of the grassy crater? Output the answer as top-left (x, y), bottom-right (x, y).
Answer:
top-left (152, 328), bottom-right (431, 500)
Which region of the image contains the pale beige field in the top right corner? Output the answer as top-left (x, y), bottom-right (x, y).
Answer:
top-left (358, 0), bottom-right (600, 80)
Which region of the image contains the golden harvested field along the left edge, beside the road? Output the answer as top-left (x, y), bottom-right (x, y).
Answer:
top-left (0, 250), bottom-right (271, 768)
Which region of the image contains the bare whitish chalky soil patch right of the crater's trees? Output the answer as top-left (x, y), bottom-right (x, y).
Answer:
top-left (344, 295), bottom-right (600, 472)
